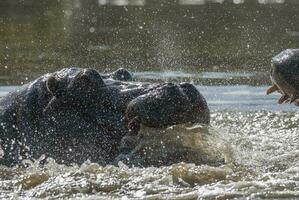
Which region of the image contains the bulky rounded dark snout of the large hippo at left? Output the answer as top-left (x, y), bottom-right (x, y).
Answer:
top-left (126, 83), bottom-right (210, 133)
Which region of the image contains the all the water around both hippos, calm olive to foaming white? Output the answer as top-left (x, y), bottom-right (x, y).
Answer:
top-left (0, 0), bottom-right (299, 200)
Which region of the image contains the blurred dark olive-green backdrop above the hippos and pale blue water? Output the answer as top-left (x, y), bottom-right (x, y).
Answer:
top-left (0, 0), bottom-right (299, 85)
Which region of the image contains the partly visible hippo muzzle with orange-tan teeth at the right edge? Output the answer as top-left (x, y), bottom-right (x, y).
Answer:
top-left (267, 49), bottom-right (299, 106)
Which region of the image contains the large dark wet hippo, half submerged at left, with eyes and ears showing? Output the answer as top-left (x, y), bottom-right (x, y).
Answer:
top-left (0, 68), bottom-right (210, 166)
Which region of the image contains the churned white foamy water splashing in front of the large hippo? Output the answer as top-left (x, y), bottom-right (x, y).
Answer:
top-left (0, 111), bottom-right (299, 199)
